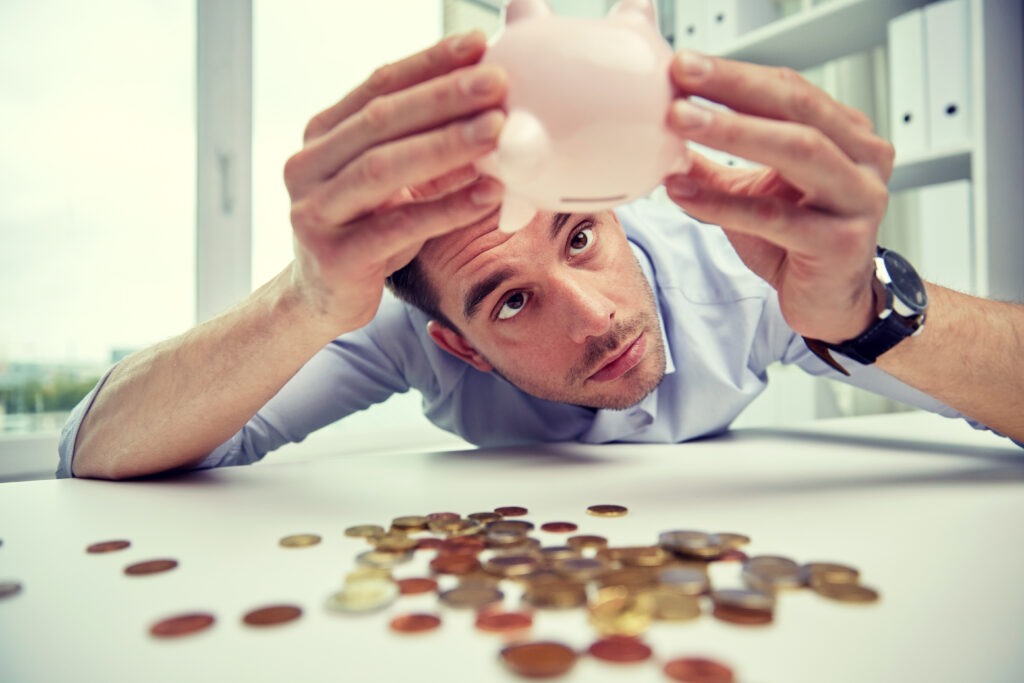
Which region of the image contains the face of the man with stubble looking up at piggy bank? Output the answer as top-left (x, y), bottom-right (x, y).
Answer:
top-left (419, 211), bottom-right (665, 410)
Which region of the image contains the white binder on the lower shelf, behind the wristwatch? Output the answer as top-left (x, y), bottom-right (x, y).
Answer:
top-left (915, 180), bottom-right (976, 294)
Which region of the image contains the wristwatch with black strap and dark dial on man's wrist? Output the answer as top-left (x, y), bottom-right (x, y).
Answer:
top-left (804, 247), bottom-right (928, 375)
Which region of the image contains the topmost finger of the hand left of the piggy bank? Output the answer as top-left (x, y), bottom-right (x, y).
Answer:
top-left (303, 30), bottom-right (487, 141)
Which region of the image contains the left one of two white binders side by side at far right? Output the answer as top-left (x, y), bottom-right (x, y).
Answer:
top-left (889, 9), bottom-right (929, 162)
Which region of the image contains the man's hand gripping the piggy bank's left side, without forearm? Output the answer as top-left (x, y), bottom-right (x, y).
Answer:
top-left (285, 31), bottom-right (507, 336)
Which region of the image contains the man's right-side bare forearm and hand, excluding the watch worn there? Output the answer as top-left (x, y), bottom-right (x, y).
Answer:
top-left (666, 50), bottom-right (1024, 440)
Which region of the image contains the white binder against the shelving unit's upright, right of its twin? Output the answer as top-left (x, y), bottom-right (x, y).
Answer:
top-left (923, 0), bottom-right (970, 151)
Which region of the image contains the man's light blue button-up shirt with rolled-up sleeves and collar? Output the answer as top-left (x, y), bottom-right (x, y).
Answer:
top-left (57, 201), bottom-right (980, 477)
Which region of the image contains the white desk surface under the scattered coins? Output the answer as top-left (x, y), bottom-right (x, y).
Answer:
top-left (0, 414), bottom-right (1024, 683)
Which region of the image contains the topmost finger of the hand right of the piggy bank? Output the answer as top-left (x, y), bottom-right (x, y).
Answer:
top-left (671, 50), bottom-right (893, 182)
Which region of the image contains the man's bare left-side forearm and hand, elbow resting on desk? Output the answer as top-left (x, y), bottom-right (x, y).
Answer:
top-left (72, 32), bottom-right (507, 478)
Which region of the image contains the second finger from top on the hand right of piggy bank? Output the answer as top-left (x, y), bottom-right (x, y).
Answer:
top-left (669, 99), bottom-right (887, 215)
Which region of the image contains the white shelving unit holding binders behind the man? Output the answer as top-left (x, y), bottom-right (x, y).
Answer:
top-left (712, 0), bottom-right (1024, 301)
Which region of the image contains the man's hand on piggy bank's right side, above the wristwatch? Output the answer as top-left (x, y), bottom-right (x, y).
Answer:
top-left (666, 50), bottom-right (894, 343)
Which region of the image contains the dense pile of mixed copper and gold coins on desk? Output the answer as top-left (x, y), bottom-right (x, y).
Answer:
top-left (326, 505), bottom-right (878, 682)
